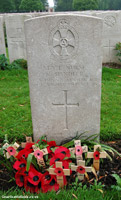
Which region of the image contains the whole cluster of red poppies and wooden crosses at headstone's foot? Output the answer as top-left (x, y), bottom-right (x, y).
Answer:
top-left (1, 136), bottom-right (107, 193)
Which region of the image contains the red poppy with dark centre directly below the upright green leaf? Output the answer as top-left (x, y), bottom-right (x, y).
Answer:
top-left (27, 166), bottom-right (42, 186)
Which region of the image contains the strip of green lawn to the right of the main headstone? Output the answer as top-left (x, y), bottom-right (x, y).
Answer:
top-left (101, 68), bottom-right (121, 140)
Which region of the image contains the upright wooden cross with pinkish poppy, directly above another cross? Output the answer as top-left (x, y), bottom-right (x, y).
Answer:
top-left (69, 140), bottom-right (88, 164)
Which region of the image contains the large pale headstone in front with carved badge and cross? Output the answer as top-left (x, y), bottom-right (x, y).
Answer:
top-left (25, 14), bottom-right (102, 143)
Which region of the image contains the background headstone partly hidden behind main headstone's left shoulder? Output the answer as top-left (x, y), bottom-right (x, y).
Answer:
top-left (5, 14), bottom-right (31, 62)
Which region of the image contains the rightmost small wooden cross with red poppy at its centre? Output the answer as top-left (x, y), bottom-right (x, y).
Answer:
top-left (87, 145), bottom-right (107, 171)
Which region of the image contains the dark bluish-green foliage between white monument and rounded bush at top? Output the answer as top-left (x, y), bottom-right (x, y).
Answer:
top-left (55, 0), bottom-right (73, 11)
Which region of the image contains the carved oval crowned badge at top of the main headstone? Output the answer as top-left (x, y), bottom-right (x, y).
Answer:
top-left (49, 19), bottom-right (79, 60)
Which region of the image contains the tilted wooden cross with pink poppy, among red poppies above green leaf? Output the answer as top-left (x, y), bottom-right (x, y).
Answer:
top-left (32, 145), bottom-right (48, 168)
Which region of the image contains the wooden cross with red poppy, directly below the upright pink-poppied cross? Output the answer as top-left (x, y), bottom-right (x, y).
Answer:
top-left (71, 160), bottom-right (92, 181)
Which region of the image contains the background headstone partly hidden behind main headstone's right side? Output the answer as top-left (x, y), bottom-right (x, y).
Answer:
top-left (93, 11), bottom-right (121, 63)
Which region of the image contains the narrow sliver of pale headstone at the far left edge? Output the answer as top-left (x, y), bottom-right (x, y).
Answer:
top-left (0, 16), bottom-right (6, 54)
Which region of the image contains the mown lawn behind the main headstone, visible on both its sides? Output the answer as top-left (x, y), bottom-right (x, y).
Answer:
top-left (0, 68), bottom-right (121, 141)
